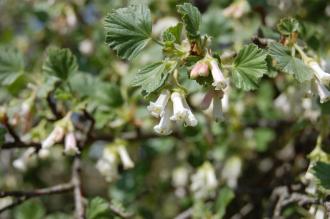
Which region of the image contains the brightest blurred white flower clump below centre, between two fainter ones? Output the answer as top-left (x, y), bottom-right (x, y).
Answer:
top-left (190, 162), bottom-right (218, 199)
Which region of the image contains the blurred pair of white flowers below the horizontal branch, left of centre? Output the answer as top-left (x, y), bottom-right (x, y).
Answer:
top-left (96, 140), bottom-right (134, 182)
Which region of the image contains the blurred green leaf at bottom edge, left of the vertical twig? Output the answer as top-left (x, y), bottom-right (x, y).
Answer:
top-left (15, 200), bottom-right (46, 219)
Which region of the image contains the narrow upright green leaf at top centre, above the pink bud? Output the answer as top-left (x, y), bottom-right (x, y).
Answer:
top-left (177, 3), bottom-right (201, 39)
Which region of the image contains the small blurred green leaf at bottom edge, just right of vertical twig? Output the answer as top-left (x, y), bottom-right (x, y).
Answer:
top-left (87, 197), bottom-right (110, 219)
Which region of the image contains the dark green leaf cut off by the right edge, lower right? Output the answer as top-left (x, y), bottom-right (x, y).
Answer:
top-left (312, 161), bottom-right (330, 189)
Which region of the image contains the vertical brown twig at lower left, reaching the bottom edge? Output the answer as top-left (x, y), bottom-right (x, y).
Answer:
top-left (72, 156), bottom-right (85, 219)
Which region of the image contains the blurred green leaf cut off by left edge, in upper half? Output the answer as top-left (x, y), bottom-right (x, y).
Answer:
top-left (0, 47), bottom-right (24, 86)
